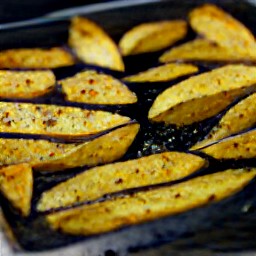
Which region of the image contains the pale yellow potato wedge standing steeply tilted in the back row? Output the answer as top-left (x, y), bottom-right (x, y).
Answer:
top-left (68, 17), bottom-right (124, 71)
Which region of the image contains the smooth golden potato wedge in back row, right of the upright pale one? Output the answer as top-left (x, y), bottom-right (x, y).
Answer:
top-left (119, 20), bottom-right (187, 56)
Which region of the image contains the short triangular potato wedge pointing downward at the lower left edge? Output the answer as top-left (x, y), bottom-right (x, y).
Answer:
top-left (0, 164), bottom-right (33, 217)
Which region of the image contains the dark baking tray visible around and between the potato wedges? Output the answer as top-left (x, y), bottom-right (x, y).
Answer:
top-left (0, 0), bottom-right (256, 256)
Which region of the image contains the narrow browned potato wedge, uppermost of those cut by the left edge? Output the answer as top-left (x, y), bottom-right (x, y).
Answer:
top-left (0, 47), bottom-right (74, 68)
